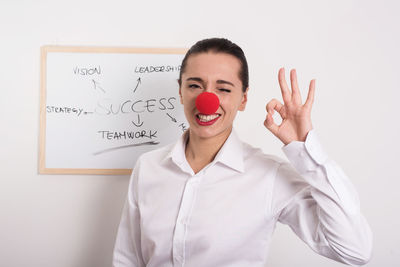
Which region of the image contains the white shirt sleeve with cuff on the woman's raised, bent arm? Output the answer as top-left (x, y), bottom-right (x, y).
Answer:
top-left (272, 130), bottom-right (372, 266)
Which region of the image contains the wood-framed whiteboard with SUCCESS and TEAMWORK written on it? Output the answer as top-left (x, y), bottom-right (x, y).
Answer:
top-left (39, 46), bottom-right (188, 174)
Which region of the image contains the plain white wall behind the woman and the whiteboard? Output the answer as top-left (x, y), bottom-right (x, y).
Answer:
top-left (0, 0), bottom-right (400, 267)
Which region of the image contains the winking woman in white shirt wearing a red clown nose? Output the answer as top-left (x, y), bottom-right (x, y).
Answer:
top-left (113, 38), bottom-right (372, 267)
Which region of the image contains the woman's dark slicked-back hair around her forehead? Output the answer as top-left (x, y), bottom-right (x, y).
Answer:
top-left (178, 38), bottom-right (249, 92)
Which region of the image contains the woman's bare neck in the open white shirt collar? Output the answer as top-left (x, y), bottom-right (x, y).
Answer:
top-left (185, 128), bottom-right (232, 173)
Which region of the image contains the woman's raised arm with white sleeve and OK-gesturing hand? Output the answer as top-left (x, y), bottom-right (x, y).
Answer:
top-left (264, 68), bottom-right (372, 265)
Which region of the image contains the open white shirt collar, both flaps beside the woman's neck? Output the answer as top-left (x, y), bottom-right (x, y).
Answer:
top-left (166, 129), bottom-right (244, 172)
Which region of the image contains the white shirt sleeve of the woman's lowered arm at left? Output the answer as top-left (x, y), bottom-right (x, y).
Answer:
top-left (113, 160), bottom-right (145, 267)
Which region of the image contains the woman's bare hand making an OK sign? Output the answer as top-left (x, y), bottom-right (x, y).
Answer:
top-left (264, 68), bottom-right (315, 145)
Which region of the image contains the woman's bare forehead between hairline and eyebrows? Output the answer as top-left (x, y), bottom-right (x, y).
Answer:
top-left (182, 52), bottom-right (241, 82)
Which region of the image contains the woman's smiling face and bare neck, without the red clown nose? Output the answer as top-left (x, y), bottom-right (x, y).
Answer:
top-left (179, 50), bottom-right (247, 151)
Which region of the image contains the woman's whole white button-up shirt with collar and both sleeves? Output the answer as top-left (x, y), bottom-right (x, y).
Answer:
top-left (113, 131), bottom-right (372, 267)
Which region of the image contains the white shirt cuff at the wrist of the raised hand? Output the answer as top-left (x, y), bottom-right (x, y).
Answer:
top-left (282, 130), bottom-right (328, 174)
